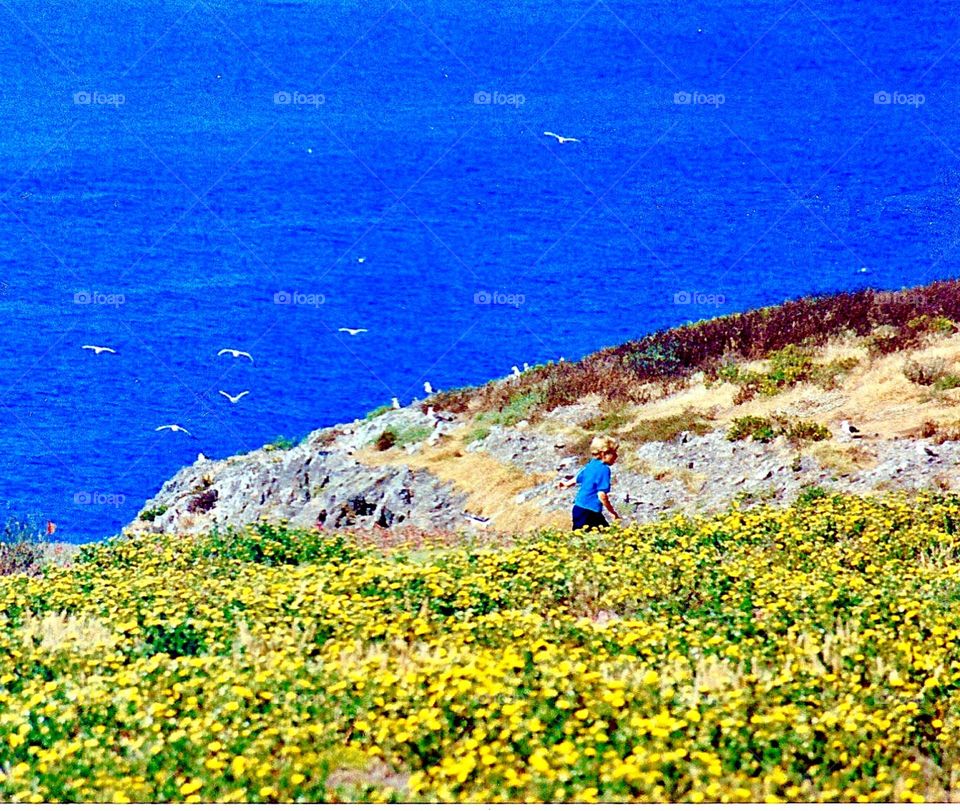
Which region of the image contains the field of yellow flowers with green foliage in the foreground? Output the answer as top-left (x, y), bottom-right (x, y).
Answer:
top-left (0, 493), bottom-right (960, 802)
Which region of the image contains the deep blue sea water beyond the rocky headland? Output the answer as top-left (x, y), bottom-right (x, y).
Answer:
top-left (0, 0), bottom-right (960, 541)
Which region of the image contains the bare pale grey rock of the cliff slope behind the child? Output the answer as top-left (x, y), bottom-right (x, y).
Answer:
top-left (128, 394), bottom-right (960, 533)
